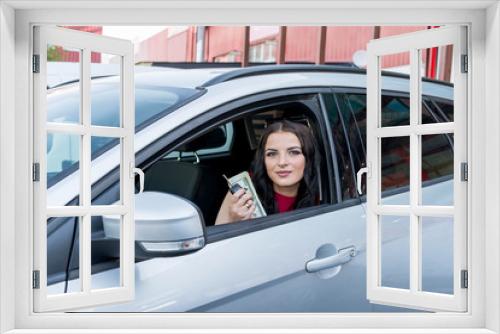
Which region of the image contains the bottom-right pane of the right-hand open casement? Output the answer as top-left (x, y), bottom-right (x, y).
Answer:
top-left (421, 217), bottom-right (453, 294)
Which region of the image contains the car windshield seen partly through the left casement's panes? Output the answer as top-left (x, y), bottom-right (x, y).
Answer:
top-left (47, 77), bottom-right (198, 187)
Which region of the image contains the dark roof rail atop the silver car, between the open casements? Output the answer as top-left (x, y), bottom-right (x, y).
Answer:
top-left (201, 64), bottom-right (366, 88)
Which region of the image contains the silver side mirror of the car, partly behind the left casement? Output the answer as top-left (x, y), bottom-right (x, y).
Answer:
top-left (103, 191), bottom-right (206, 258)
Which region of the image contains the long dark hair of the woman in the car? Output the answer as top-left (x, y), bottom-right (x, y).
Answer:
top-left (252, 120), bottom-right (319, 214)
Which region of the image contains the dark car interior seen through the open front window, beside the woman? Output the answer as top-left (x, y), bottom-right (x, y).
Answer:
top-left (144, 102), bottom-right (328, 226)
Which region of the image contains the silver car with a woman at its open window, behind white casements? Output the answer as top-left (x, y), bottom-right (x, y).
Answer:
top-left (47, 65), bottom-right (453, 312)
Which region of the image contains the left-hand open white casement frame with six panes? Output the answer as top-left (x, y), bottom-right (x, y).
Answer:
top-left (33, 26), bottom-right (135, 312)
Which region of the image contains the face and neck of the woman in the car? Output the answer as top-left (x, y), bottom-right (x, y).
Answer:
top-left (264, 131), bottom-right (306, 196)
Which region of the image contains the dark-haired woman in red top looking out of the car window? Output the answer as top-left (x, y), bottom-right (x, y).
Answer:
top-left (215, 120), bottom-right (319, 225)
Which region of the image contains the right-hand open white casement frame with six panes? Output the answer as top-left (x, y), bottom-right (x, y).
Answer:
top-left (366, 26), bottom-right (468, 312)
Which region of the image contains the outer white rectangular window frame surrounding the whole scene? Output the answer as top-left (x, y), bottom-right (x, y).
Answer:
top-left (0, 0), bottom-right (500, 334)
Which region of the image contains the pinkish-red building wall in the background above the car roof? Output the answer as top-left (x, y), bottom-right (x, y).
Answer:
top-left (136, 26), bottom-right (451, 81)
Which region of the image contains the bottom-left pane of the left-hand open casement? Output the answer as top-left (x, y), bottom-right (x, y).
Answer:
top-left (47, 217), bottom-right (81, 295)
